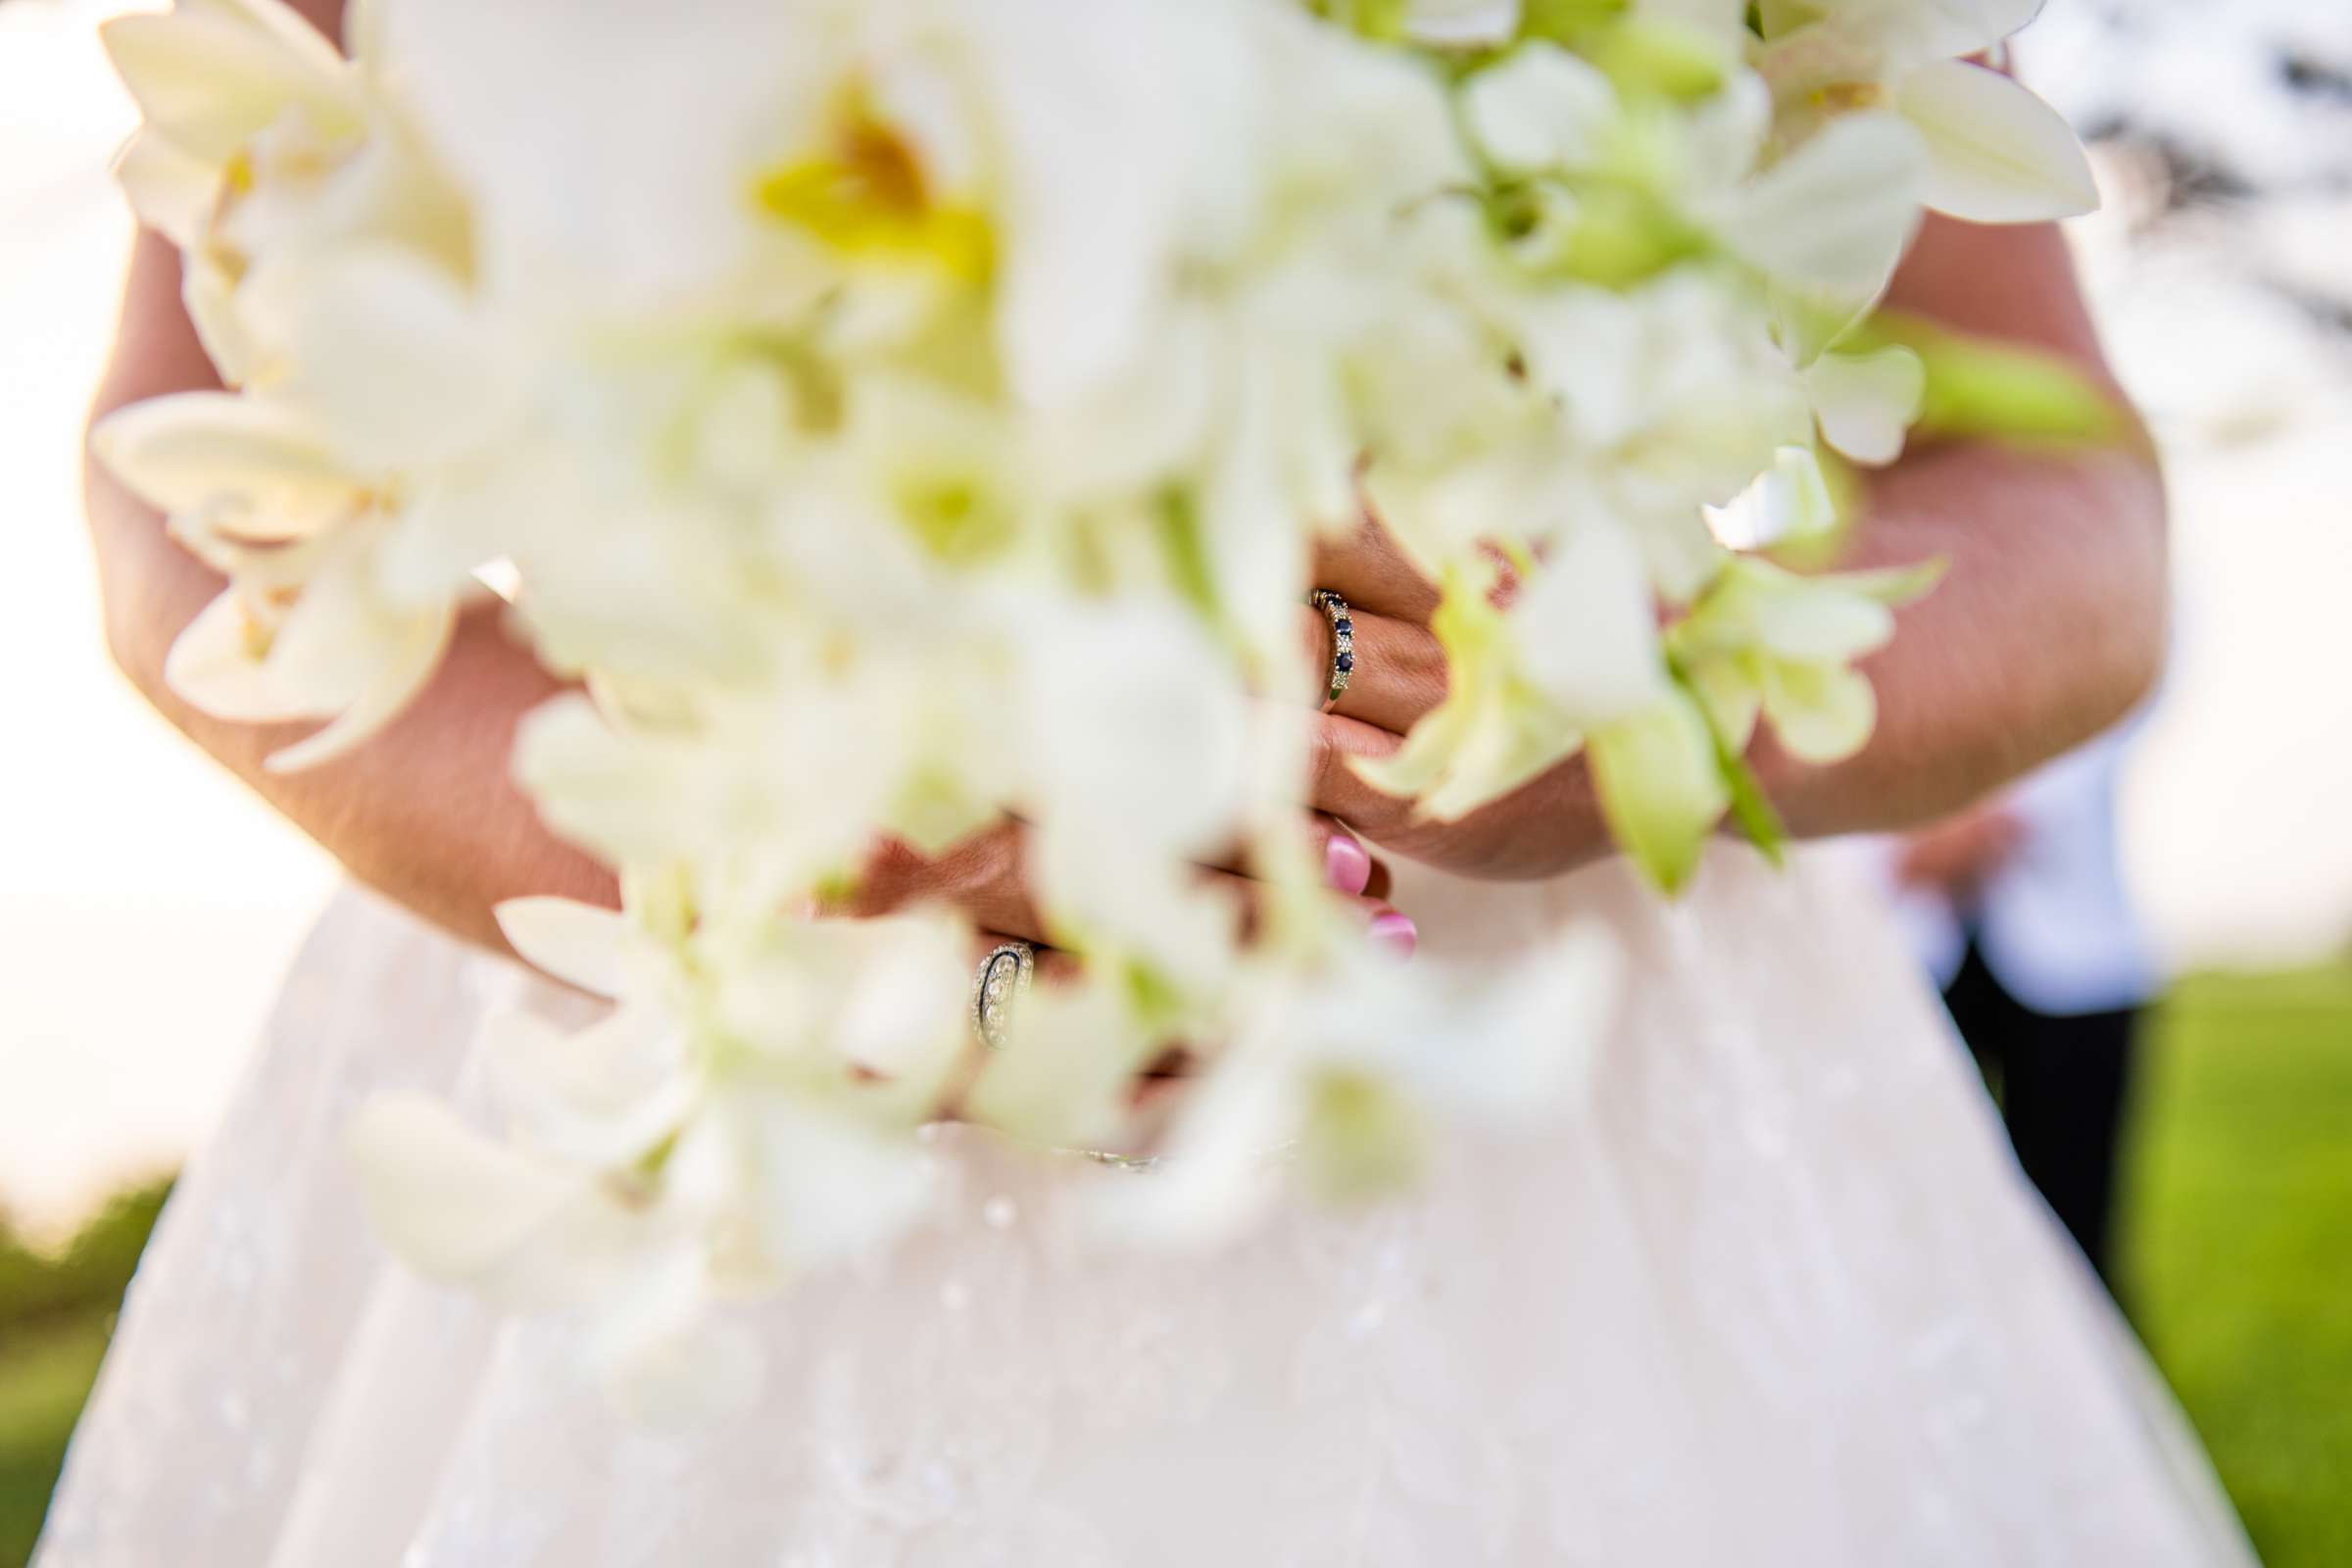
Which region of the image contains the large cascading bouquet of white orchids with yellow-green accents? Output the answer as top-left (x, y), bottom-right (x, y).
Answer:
top-left (99, 0), bottom-right (2093, 1394)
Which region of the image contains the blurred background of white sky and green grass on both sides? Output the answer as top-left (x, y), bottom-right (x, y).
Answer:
top-left (0, 0), bottom-right (2352, 1568)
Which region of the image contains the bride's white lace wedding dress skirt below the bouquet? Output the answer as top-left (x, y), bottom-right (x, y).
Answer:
top-left (37, 849), bottom-right (2251, 1568)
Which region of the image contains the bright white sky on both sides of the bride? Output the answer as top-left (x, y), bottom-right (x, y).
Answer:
top-left (0, 0), bottom-right (2352, 1227)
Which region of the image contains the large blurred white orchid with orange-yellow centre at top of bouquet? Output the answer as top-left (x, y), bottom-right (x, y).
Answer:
top-left (386, 0), bottom-right (1265, 405)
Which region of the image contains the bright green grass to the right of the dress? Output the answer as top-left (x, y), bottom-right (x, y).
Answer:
top-left (2124, 971), bottom-right (2352, 1568)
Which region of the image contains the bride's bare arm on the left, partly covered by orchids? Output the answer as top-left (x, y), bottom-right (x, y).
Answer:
top-left (89, 235), bottom-right (616, 948)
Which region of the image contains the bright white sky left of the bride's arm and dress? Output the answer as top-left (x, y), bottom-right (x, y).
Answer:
top-left (0, 0), bottom-right (334, 1225)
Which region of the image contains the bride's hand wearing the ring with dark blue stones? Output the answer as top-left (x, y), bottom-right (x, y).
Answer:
top-left (1298, 522), bottom-right (1609, 882)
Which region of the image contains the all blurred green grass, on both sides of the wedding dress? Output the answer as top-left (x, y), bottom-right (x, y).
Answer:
top-left (0, 968), bottom-right (2352, 1568)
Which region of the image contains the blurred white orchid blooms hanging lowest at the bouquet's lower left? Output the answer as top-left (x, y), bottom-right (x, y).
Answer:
top-left (351, 898), bottom-right (969, 1415)
